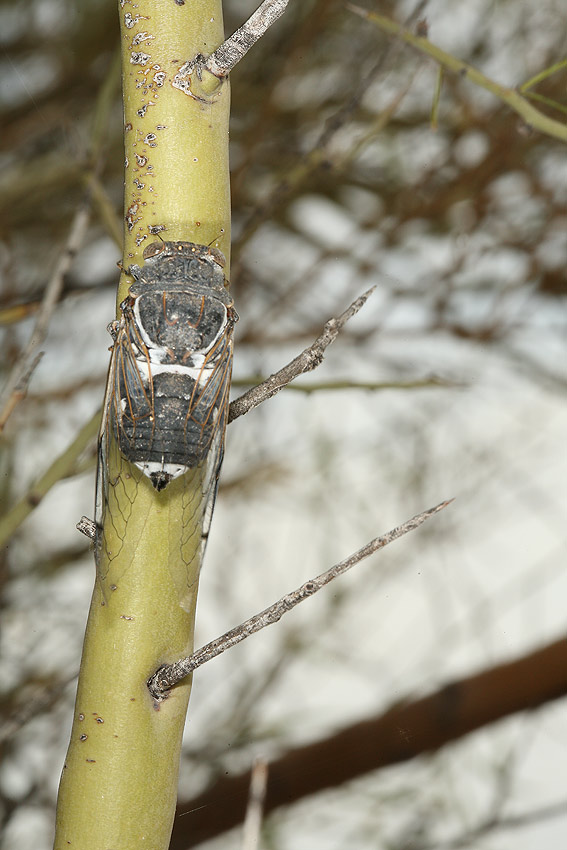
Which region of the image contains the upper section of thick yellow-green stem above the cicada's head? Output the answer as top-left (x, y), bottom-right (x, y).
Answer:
top-left (118, 0), bottom-right (230, 301)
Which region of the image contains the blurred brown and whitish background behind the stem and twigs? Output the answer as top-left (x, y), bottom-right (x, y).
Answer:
top-left (0, 0), bottom-right (567, 850)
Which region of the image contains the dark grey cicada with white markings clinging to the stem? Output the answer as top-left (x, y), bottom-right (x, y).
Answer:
top-left (96, 242), bottom-right (238, 568)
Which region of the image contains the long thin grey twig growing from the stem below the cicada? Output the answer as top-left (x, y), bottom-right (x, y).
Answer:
top-left (148, 499), bottom-right (453, 701)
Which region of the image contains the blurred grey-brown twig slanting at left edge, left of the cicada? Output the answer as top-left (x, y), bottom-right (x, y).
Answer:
top-left (0, 199), bottom-right (90, 434)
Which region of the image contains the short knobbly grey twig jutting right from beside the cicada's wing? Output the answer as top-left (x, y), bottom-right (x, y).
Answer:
top-left (228, 287), bottom-right (375, 422)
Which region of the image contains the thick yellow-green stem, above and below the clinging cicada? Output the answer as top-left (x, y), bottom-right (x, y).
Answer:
top-left (55, 0), bottom-right (230, 850)
